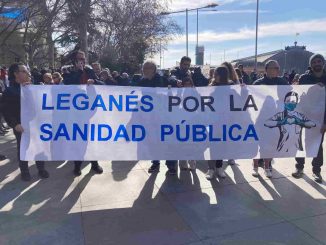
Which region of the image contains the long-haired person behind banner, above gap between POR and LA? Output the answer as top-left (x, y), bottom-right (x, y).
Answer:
top-left (205, 66), bottom-right (235, 180)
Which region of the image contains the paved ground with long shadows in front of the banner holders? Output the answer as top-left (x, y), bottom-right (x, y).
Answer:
top-left (0, 135), bottom-right (326, 245)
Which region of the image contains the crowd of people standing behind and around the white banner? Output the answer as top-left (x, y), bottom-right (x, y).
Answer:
top-left (0, 51), bottom-right (326, 183)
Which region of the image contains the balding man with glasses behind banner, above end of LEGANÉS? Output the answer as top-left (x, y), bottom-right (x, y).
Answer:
top-left (135, 61), bottom-right (177, 175)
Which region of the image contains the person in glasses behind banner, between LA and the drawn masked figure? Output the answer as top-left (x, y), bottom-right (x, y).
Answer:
top-left (252, 60), bottom-right (289, 178)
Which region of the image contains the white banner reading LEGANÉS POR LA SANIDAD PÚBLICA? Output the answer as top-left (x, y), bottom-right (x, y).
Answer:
top-left (20, 85), bottom-right (325, 161)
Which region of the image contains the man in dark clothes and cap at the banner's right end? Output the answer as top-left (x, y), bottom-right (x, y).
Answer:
top-left (292, 54), bottom-right (326, 183)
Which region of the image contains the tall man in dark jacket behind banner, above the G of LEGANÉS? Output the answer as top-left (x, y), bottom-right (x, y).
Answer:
top-left (63, 50), bottom-right (103, 176)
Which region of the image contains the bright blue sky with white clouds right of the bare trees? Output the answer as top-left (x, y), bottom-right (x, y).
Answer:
top-left (154, 0), bottom-right (326, 68)
